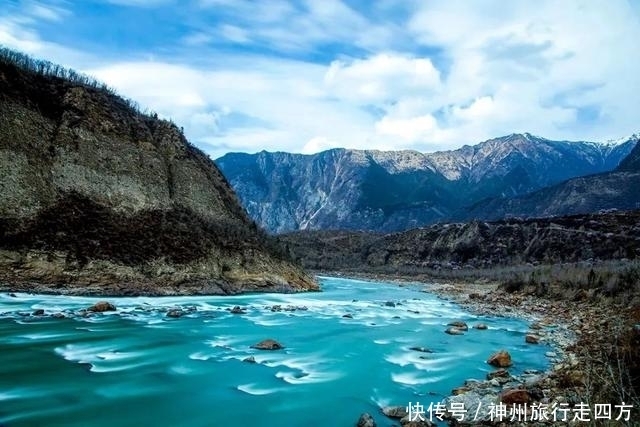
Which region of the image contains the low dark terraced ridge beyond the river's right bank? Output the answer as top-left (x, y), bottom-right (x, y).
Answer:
top-left (281, 210), bottom-right (640, 274)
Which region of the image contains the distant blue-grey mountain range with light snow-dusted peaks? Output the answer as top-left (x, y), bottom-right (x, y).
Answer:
top-left (216, 133), bottom-right (638, 232)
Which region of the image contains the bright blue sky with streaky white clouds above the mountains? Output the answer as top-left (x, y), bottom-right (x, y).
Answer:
top-left (0, 0), bottom-right (640, 158)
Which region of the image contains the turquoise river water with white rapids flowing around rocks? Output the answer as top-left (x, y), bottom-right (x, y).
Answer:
top-left (0, 277), bottom-right (549, 427)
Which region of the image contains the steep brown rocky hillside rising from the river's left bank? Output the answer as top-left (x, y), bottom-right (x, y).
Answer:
top-left (0, 46), bottom-right (317, 294)
